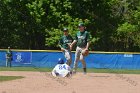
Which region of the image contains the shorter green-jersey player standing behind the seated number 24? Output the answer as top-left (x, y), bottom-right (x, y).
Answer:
top-left (59, 28), bottom-right (73, 66)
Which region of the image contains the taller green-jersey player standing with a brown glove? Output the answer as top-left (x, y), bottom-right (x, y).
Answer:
top-left (70, 23), bottom-right (91, 74)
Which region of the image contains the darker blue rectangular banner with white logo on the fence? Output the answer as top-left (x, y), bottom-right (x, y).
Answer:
top-left (12, 52), bottom-right (32, 64)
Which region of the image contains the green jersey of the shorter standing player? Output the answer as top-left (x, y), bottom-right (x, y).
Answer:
top-left (59, 35), bottom-right (73, 49)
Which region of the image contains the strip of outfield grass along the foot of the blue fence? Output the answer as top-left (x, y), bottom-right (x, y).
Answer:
top-left (0, 67), bottom-right (140, 74)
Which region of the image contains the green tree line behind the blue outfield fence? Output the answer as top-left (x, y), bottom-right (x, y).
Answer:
top-left (0, 0), bottom-right (140, 52)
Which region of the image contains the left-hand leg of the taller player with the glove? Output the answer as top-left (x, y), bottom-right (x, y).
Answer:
top-left (73, 47), bottom-right (80, 73)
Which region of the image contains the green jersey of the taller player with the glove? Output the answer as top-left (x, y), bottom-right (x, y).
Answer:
top-left (75, 31), bottom-right (91, 48)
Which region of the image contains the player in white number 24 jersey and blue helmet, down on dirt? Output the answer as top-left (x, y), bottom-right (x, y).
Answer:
top-left (52, 58), bottom-right (72, 77)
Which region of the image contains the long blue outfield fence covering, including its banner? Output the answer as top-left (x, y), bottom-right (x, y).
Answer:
top-left (0, 51), bottom-right (140, 69)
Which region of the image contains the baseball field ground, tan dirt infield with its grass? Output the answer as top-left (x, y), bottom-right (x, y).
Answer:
top-left (0, 67), bottom-right (140, 93)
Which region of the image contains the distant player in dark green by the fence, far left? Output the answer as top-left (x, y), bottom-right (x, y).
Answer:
top-left (6, 47), bottom-right (12, 67)
